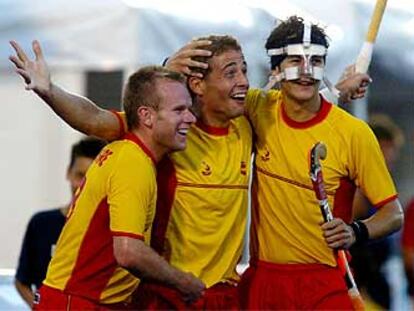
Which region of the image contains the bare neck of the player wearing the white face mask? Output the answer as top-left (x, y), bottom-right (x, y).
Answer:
top-left (282, 92), bottom-right (322, 122)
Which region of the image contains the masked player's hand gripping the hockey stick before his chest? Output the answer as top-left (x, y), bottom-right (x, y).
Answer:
top-left (321, 218), bottom-right (355, 249)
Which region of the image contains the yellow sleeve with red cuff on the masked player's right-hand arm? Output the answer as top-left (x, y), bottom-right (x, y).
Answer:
top-left (350, 120), bottom-right (397, 207)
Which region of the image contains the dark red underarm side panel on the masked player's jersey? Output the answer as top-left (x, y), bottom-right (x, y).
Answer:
top-left (333, 178), bottom-right (356, 223)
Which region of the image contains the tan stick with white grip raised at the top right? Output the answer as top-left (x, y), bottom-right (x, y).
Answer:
top-left (355, 0), bottom-right (387, 73)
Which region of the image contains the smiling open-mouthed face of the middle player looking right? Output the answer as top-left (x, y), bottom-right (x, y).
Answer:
top-left (195, 50), bottom-right (249, 123)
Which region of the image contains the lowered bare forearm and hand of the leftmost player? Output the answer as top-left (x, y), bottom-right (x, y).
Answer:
top-left (114, 236), bottom-right (205, 302)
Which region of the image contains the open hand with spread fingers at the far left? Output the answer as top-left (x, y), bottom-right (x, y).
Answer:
top-left (9, 40), bottom-right (51, 95)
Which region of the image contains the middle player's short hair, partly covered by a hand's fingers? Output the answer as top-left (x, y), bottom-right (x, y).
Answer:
top-left (191, 35), bottom-right (242, 78)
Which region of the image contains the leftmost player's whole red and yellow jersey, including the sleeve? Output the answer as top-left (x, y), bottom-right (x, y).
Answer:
top-left (44, 133), bottom-right (157, 304)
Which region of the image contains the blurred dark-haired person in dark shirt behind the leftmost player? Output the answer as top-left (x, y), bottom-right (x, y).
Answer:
top-left (15, 137), bottom-right (106, 307)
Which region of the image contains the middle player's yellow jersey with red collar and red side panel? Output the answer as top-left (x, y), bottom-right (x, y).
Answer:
top-left (113, 113), bottom-right (252, 287)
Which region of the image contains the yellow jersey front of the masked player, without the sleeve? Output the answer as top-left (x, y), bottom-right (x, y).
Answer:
top-left (252, 92), bottom-right (353, 265)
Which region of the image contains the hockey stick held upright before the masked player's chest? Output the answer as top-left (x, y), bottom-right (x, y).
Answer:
top-left (309, 142), bottom-right (365, 310)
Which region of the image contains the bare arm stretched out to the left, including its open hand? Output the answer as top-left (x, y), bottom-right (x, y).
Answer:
top-left (9, 40), bottom-right (121, 140)
